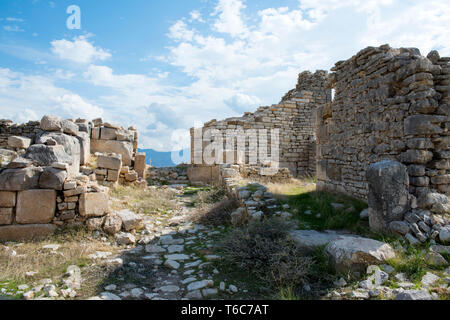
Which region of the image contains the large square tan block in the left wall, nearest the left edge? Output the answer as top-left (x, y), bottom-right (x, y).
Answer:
top-left (16, 189), bottom-right (56, 224)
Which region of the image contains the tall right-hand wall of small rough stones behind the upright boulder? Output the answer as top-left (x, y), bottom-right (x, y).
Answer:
top-left (317, 45), bottom-right (450, 199)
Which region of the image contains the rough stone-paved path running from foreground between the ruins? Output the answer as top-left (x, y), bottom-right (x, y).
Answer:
top-left (91, 190), bottom-right (239, 300)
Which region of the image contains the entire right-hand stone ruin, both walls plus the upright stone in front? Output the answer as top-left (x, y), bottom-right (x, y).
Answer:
top-left (188, 45), bottom-right (450, 243)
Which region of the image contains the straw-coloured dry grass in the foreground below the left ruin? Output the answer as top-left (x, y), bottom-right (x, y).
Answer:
top-left (0, 229), bottom-right (113, 284)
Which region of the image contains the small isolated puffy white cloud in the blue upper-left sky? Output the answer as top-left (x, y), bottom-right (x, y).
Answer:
top-left (51, 36), bottom-right (111, 63)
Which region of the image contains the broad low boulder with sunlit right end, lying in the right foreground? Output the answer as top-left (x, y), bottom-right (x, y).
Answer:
top-left (325, 236), bottom-right (395, 272)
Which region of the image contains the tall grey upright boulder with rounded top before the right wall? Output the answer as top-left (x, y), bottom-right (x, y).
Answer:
top-left (366, 160), bottom-right (410, 233)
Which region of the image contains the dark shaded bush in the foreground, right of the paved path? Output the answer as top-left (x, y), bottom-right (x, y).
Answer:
top-left (219, 218), bottom-right (313, 287)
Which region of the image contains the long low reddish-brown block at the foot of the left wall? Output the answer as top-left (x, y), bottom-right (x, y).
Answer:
top-left (0, 224), bottom-right (56, 241)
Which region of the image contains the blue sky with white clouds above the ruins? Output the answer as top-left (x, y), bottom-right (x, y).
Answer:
top-left (0, 0), bottom-right (450, 151)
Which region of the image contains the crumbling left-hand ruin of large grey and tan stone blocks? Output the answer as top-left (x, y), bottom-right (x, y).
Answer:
top-left (0, 116), bottom-right (147, 241)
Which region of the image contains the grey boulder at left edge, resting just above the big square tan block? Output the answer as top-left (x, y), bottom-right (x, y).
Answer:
top-left (0, 167), bottom-right (43, 191)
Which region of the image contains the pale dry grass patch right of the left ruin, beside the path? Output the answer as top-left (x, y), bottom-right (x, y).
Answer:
top-left (111, 186), bottom-right (177, 214)
